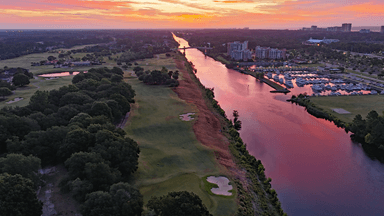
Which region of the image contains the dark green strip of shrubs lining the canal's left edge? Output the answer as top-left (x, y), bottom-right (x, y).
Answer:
top-left (184, 52), bottom-right (286, 216)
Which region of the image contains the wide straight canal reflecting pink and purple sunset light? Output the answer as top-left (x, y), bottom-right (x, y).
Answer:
top-left (175, 34), bottom-right (384, 215)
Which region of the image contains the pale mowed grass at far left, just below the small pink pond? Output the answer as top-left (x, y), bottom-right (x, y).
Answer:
top-left (0, 75), bottom-right (73, 109)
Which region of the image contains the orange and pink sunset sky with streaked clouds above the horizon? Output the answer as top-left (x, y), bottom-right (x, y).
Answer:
top-left (0, 0), bottom-right (384, 29)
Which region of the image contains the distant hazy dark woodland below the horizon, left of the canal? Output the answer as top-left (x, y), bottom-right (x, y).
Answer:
top-left (0, 30), bottom-right (177, 62)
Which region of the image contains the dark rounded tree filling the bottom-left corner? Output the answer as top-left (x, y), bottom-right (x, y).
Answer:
top-left (0, 173), bottom-right (43, 216)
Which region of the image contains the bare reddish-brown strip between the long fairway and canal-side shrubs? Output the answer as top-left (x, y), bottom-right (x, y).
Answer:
top-left (174, 57), bottom-right (239, 173)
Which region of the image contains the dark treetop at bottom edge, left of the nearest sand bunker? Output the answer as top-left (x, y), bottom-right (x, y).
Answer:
top-left (147, 191), bottom-right (211, 216)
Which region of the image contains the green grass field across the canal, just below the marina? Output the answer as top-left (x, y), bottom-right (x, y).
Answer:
top-left (311, 95), bottom-right (384, 122)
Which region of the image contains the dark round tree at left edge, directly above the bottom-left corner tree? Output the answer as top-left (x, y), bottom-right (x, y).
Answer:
top-left (0, 154), bottom-right (41, 187)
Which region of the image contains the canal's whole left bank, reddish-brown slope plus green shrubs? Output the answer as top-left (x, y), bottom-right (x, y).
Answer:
top-left (175, 51), bottom-right (285, 215)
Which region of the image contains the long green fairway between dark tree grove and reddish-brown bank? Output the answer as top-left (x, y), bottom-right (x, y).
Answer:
top-left (125, 73), bottom-right (237, 215)
